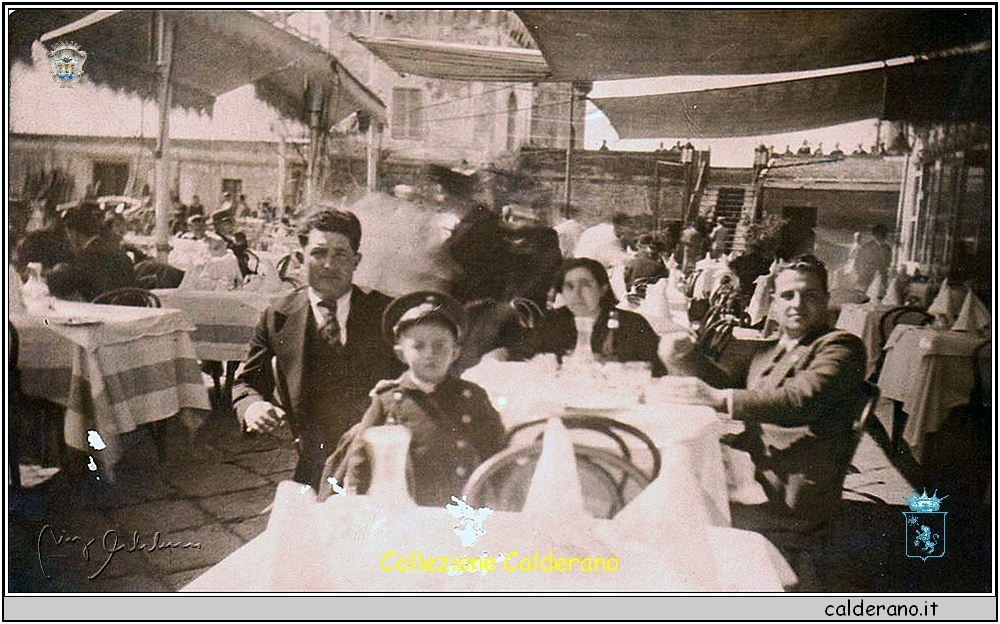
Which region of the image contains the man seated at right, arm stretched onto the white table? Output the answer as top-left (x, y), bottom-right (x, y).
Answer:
top-left (659, 256), bottom-right (869, 580)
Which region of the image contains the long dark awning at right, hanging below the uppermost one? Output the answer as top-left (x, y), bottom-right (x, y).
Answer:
top-left (592, 50), bottom-right (992, 139)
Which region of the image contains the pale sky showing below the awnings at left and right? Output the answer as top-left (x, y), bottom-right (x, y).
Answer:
top-left (9, 29), bottom-right (877, 167)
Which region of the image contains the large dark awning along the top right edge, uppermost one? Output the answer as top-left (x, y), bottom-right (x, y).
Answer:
top-left (515, 9), bottom-right (993, 81)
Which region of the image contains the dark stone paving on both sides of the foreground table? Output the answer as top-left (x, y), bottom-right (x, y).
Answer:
top-left (7, 404), bottom-right (992, 593)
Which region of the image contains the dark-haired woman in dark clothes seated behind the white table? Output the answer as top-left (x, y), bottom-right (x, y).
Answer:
top-left (533, 258), bottom-right (666, 376)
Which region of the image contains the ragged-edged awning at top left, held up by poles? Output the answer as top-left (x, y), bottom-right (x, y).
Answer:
top-left (16, 10), bottom-right (386, 124)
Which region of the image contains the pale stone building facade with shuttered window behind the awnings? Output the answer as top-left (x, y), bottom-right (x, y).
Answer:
top-left (276, 9), bottom-right (584, 166)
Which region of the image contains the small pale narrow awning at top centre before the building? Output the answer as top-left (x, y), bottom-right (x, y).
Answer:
top-left (351, 33), bottom-right (551, 82)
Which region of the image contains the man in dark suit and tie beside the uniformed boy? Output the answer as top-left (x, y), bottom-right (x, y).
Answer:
top-left (233, 210), bottom-right (403, 488)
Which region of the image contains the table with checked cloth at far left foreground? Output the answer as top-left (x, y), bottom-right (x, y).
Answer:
top-left (10, 299), bottom-right (209, 480)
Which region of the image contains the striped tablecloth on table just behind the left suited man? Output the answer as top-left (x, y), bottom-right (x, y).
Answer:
top-left (153, 288), bottom-right (287, 362)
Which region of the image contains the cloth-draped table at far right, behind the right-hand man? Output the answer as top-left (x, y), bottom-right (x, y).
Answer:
top-left (878, 325), bottom-right (989, 462)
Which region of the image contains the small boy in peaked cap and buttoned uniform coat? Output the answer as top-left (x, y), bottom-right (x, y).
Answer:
top-left (320, 291), bottom-right (504, 507)
